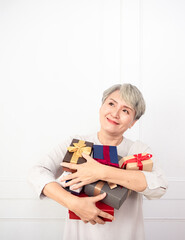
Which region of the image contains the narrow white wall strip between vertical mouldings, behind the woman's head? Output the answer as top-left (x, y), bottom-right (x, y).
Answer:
top-left (120, 0), bottom-right (141, 140)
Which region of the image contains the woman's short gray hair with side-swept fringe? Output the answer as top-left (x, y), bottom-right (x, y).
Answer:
top-left (102, 83), bottom-right (146, 120)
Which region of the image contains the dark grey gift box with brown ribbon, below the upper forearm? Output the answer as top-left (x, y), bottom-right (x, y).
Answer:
top-left (84, 181), bottom-right (129, 209)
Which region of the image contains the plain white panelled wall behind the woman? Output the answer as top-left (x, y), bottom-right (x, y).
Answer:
top-left (0, 0), bottom-right (185, 240)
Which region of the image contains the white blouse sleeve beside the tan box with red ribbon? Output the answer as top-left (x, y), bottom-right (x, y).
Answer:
top-left (128, 142), bottom-right (168, 199)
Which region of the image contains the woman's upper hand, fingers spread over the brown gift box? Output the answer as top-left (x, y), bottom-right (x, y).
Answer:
top-left (60, 154), bottom-right (105, 190)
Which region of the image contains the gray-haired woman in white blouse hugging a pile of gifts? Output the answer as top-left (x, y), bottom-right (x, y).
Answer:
top-left (29, 84), bottom-right (167, 240)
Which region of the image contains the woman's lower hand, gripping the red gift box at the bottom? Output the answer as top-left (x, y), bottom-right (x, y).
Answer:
top-left (71, 193), bottom-right (114, 225)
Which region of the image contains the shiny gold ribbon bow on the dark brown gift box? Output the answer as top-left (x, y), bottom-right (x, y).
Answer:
top-left (67, 140), bottom-right (91, 163)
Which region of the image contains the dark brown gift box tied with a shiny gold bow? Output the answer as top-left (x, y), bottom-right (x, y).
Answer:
top-left (63, 138), bottom-right (93, 172)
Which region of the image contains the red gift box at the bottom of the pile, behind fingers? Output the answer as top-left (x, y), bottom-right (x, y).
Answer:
top-left (68, 193), bottom-right (114, 222)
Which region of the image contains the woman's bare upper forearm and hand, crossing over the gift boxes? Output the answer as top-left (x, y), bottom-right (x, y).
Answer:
top-left (61, 154), bottom-right (147, 192)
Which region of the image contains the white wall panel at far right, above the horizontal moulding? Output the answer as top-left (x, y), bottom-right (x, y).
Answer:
top-left (142, 0), bottom-right (185, 180)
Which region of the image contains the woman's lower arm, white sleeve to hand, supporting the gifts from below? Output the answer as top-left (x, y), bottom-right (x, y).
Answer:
top-left (28, 143), bottom-right (113, 224)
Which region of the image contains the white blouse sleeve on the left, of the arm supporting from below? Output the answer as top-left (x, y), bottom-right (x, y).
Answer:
top-left (28, 139), bottom-right (71, 198)
